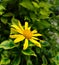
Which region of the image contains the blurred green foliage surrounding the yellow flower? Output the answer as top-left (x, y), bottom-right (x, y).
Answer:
top-left (0, 0), bottom-right (59, 65)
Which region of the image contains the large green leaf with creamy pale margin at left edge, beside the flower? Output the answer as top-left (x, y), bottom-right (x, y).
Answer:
top-left (0, 40), bottom-right (15, 49)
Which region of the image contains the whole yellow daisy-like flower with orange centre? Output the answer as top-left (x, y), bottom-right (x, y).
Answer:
top-left (10, 21), bottom-right (42, 50)
